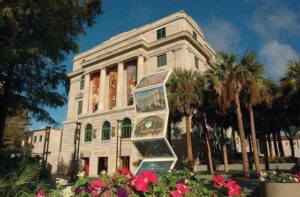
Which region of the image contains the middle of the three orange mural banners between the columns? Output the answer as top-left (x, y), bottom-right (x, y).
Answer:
top-left (108, 68), bottom-right (117, 109)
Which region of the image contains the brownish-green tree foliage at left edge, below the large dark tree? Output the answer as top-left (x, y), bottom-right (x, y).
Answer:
top-left (3, 111), bottom-right (30, 153)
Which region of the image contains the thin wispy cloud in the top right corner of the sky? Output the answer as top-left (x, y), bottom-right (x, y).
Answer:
top-left (251, 1), bottom-right (300, 40)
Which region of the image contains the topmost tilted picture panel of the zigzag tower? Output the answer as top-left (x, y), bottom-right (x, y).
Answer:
top-left (136, 70), bottom-right (169, 89)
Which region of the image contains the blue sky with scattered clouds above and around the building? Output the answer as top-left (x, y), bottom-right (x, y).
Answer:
top-left (31, 0), bottom-right (300, 130)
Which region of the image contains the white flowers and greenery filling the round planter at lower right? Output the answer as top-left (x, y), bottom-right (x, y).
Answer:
top-left (259, 170), bottom-right (300, 183)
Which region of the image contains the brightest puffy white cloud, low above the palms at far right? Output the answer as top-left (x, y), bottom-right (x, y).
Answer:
top-left (259, 40), bottom-right (299, 80)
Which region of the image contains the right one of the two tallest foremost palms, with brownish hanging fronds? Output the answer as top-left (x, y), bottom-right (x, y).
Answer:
top-left (241, 52), bottom-right (266, 174)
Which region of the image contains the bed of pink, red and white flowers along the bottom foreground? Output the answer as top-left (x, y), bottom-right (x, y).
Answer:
top-left (37, 168), bottom-right (246, 197)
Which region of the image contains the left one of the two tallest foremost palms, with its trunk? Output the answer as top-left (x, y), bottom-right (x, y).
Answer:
top-left (207, 52), bottom-right (250, 177)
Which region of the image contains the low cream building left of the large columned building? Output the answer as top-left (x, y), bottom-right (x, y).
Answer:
top-left (28, 128), bottom-right (63, 174)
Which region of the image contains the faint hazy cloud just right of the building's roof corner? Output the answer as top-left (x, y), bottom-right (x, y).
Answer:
top-left (203, 18), bottom-right (239, 52)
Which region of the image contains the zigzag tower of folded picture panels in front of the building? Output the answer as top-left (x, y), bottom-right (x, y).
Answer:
top-left (131, 70), bottom-right (177, 175)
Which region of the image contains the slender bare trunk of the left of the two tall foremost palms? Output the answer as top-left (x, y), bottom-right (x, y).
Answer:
top-left (235, 94), bottom-right (250, 177)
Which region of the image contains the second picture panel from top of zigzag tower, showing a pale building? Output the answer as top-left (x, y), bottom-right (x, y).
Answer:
top-left (135, 87), bottom-right (166, 112)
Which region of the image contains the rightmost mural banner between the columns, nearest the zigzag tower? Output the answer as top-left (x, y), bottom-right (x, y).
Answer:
top-left (127, 61), bottom-right (137, 105)
